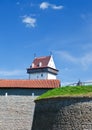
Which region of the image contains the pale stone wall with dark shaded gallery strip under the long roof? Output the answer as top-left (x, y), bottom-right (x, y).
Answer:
top-left (0, 88), bottom-right (47, 130)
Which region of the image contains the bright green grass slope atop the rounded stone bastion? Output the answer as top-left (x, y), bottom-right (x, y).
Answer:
top-left (37, 86), bottom-right (92, 100)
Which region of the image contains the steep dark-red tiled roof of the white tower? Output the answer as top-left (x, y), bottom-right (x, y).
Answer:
top-left (30, 56), bottom-right (51, 68)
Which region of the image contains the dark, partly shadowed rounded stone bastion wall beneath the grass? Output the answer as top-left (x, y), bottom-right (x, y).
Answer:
top-left (32, 97), bottom-right (92, 130)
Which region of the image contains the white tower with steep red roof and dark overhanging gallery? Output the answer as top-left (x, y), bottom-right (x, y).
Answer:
top-left (27, 56), bottom-right (58, 79)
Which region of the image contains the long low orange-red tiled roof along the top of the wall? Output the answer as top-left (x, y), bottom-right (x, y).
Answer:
top-left (0, 79), bottom-right (60, 88)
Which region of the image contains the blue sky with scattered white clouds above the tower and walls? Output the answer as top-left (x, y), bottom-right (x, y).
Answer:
top-left (0, 0), bottom-right (92, 83)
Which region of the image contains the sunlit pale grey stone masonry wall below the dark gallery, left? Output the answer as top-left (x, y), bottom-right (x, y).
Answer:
top-left (0, 96), bottom-right (35, 130)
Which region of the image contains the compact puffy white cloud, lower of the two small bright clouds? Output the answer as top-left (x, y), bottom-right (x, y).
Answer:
top-left (22, 16), bottom-right (36, 27)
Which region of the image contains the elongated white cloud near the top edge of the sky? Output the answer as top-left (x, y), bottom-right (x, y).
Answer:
top-left (40, 2), bottom-right (63, 10)
